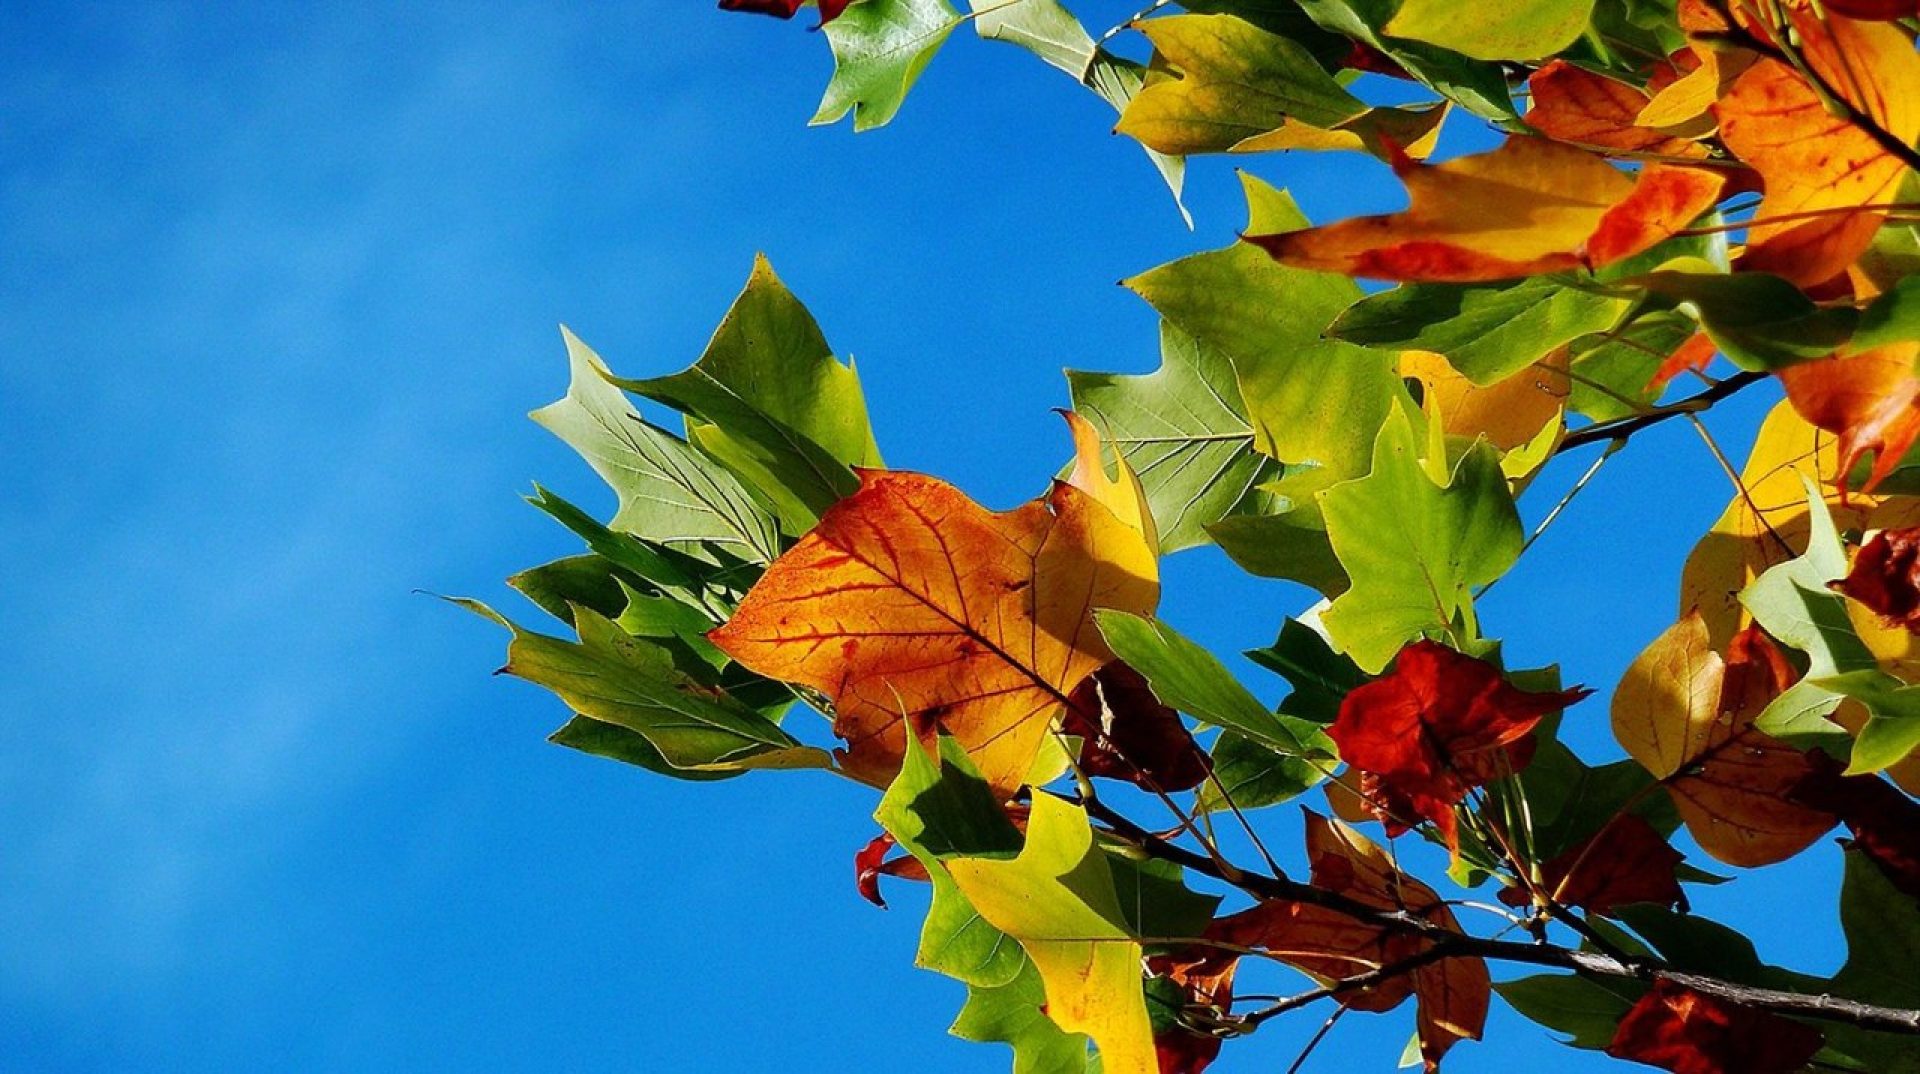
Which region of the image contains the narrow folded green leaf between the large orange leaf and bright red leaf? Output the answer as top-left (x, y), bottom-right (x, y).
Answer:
top-left (1094, 611), bottom-right (1336, 759)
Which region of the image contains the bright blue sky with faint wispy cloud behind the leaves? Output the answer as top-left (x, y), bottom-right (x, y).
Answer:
top-left (0, 0), bottom-right (1841, 1074)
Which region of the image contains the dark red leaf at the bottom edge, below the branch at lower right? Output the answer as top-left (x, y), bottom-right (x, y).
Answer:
top-left (1607, 978), bottom-right (1826, 1074)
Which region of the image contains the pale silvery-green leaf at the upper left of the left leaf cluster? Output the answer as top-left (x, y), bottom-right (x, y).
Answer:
top-left (532, 329), bottom-right (780, 563)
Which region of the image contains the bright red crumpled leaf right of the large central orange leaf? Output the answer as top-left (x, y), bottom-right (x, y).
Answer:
top-left (1329, 640), bottom-right (1588, 849)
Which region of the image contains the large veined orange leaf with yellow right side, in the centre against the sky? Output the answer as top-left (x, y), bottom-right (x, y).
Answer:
top-left (708, 420), bottom-right (1160, 795)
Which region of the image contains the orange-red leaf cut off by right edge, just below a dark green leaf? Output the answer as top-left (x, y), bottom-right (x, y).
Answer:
top-left (1780, 344), bottom-right (1920, 492)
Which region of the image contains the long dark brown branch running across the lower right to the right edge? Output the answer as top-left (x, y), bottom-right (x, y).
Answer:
top-left (1083, 801), bottom-right (1920, 1036)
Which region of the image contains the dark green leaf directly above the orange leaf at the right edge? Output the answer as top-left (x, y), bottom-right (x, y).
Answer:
top-left (1628, 263), bottom-right (1859, 371)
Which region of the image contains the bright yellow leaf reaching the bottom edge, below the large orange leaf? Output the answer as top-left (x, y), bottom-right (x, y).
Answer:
top-left (947, 793), bottom-right (1160, 1074)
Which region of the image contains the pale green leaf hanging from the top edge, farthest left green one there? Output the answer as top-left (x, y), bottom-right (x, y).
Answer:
top-left (810, 0), bottom-right (960, 131)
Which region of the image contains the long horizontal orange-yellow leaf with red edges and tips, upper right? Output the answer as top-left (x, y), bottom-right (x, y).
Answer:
top-left (1248, 138), bottom-right (1724, 282)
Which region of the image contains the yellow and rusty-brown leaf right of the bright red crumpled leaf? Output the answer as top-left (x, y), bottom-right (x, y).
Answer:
top-left (1613, 611), bottom-right (1834, 867)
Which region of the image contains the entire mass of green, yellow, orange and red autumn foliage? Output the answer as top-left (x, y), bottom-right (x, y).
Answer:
top-left (467, 0), bottom-right (1920, 1074)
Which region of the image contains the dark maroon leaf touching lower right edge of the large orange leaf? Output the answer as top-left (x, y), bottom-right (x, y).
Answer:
top-left (1060, 661), bottom-right (1213, 792)
